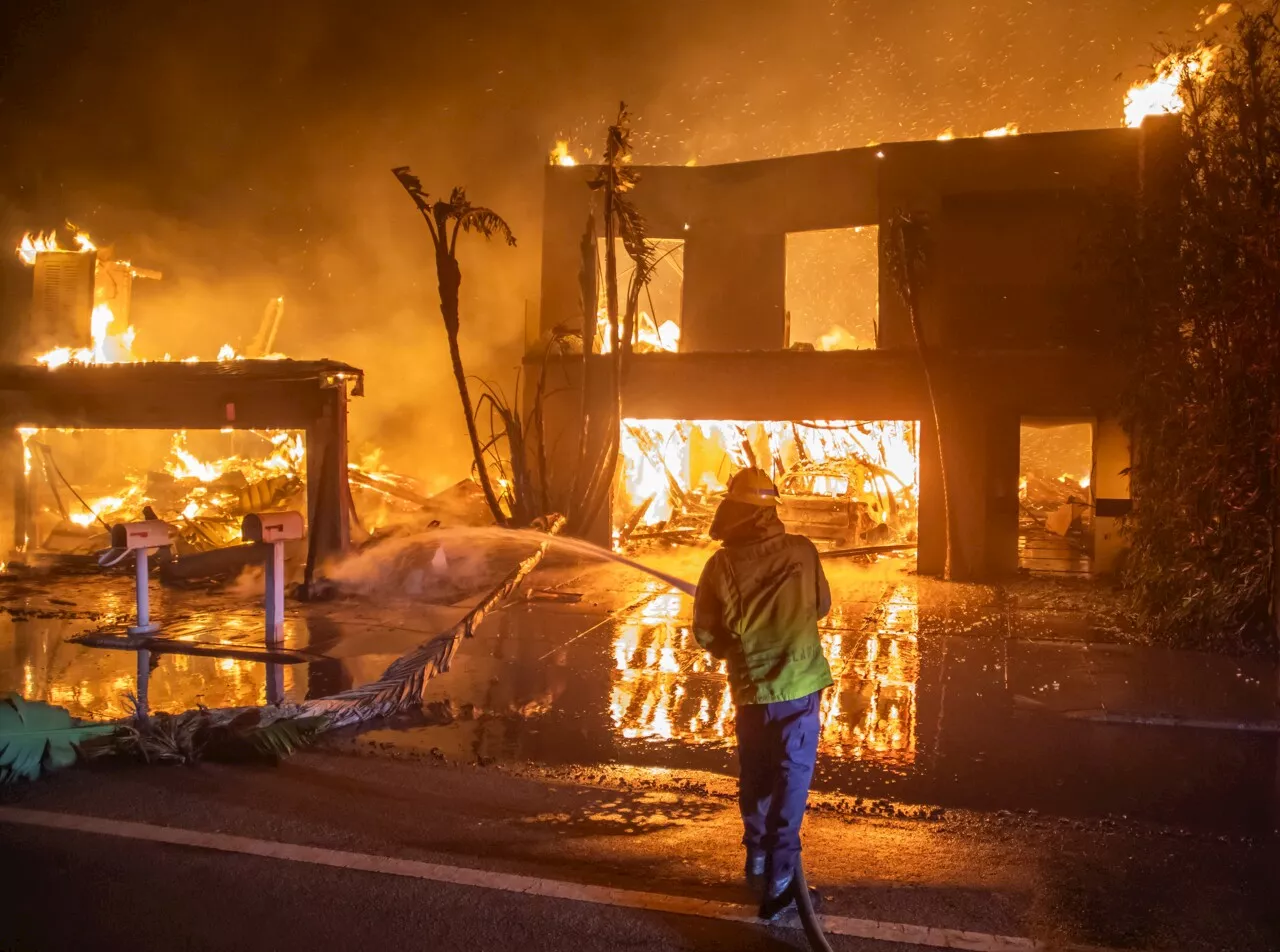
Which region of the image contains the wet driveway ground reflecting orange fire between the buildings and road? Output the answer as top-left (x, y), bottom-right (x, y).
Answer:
top-left (0, 566), bottom-right (1280, 829)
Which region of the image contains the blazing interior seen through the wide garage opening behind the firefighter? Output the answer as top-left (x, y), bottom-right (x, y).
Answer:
top-left (613, 418), bottom-right (919, 546)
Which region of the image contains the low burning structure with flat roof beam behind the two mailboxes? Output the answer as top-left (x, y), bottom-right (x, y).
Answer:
top-left (0, 226), bottom-right (364, 575)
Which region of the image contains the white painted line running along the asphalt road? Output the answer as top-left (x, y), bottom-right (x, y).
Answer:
top-left (0, 806), bottom-right (1106, 952)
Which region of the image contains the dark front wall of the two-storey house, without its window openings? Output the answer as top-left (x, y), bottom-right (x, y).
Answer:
top-left (540, 118), bottom-right (1180, 578)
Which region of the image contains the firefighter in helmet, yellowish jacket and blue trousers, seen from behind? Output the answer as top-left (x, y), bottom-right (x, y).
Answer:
top-left (694, 467), bottom-right (832, 919)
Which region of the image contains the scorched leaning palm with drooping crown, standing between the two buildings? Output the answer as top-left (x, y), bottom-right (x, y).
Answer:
top-left (392, 171), bottom-right (516, 525)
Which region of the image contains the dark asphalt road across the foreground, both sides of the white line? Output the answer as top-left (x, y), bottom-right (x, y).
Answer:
top-left (0, 751), bottom-right (1280, 952)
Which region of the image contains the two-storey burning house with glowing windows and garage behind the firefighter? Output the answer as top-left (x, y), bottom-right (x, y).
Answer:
top-left (526, 118), bottom-right (1181, 578)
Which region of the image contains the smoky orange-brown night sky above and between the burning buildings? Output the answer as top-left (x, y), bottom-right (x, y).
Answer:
top-left (0, 0), bottom-right (1202, 483)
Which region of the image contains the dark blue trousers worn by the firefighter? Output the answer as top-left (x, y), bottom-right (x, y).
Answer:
top-left (737, 691), bottom-right (822, 883)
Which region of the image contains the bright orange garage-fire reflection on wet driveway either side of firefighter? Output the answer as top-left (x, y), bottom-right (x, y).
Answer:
top-left (609, 582), bottom-right (920, 764)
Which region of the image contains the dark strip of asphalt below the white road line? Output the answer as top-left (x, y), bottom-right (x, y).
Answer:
top-left (0, 828), bottom-right (905, 952)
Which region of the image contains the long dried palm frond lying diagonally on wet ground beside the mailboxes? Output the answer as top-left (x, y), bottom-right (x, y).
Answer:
top-left (300, 516), bottom-right (564, 728)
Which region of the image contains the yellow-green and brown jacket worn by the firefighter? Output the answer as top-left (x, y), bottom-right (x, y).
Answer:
top-left (694, 532), bottom-right (832, 705)
